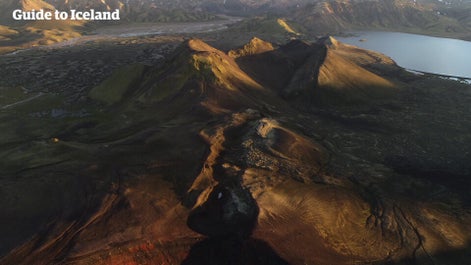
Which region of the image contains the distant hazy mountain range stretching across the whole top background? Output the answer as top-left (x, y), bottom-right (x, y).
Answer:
top-left (0, 0), bottom-right (471, 53)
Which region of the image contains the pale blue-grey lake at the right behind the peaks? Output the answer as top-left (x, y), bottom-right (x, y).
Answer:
top-left (335, 31), bottom-right (471, 78)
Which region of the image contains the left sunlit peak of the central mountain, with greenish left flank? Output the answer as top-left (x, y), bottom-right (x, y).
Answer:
top-left (90, 39), bottom-right (264, 113)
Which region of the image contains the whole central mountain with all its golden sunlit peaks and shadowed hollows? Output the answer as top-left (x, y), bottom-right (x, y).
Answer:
top-left (91, 35), bottom-right (395, 109)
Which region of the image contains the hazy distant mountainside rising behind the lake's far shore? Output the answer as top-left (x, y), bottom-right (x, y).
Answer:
top-left (290, 0), bottom-right (471, 38)
